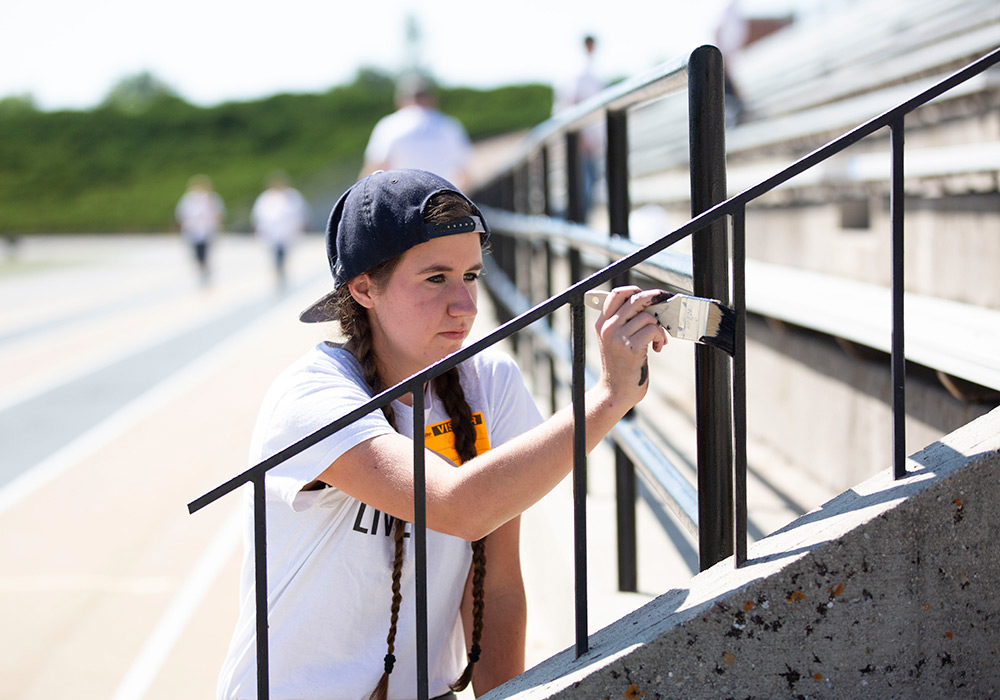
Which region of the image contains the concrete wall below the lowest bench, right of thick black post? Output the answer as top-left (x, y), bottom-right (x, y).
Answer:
top-left (747, 319), bottom-right (996, 493)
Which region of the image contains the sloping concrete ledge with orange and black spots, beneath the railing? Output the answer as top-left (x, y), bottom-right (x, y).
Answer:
top-left (486, 409), bottom-right (1000, 700)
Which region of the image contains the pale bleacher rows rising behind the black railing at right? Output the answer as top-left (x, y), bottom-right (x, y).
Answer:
top-left (630, 0), bottom-right (1000, 400)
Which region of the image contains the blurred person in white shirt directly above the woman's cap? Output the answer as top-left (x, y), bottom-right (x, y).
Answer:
top-left (361, 73), bottom-right (472, 189)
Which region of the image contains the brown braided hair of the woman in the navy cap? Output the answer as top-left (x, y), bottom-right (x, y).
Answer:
top-left (331, 192), bottom-right (486, 700)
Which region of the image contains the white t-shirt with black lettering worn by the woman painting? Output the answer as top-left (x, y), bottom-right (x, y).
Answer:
top-left (218, 343), bottom-right (541, 700)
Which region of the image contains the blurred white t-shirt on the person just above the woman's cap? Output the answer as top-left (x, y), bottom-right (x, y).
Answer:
top-left (365, 105), bottom-right (472, 186)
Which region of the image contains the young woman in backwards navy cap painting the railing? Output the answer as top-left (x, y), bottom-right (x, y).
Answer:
top-left (218, 170), bottom-right (667, 700)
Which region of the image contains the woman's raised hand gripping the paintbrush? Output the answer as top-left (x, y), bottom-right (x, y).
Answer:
top-left (594, 287), bottom-right (667, 408)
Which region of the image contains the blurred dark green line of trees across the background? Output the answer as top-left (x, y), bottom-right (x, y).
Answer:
top-left (0, 69), bottom-right (552, 235)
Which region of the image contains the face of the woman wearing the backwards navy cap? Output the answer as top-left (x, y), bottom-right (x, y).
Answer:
top-left (351, 233), bottom-right (483, 386)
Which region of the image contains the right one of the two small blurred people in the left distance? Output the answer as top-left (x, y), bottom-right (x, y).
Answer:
top-left (250, 172), bottom-right (309, 288)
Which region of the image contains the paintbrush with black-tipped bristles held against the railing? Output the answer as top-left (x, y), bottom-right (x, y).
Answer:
top-left (583, 289), bottom-right (736, 355)
